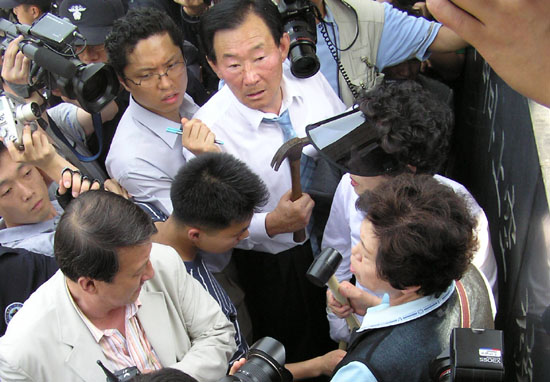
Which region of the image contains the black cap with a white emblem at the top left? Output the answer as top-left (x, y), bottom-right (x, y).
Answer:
top-left (59, 0), bottom-right (124, 45)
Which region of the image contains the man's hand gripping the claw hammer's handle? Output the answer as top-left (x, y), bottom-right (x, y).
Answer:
top-left (265, 190), bottom-right (315, 237)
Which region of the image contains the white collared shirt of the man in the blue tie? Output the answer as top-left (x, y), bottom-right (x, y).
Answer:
top-left (195, 62), bottom-right (345, 253)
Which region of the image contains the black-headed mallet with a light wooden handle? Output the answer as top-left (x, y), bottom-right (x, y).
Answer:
top-left (306, 248), bottom-right (361, 330)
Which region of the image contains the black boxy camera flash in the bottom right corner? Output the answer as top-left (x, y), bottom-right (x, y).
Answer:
top-left (430, 328), bottom-right (504, 382)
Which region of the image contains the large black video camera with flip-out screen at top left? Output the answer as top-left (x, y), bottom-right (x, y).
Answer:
top-left (0, 13), bottom-right (119, 113)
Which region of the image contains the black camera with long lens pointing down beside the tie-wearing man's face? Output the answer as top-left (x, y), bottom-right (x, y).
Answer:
top-left (278, 0), bottom-right (320, 78)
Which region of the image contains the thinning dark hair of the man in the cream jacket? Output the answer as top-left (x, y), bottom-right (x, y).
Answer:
top-left (54, 190), bottom-right (156, 282)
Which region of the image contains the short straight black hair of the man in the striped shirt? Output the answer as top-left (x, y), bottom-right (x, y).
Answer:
top-left (170, 153), bottom-right (269, 230)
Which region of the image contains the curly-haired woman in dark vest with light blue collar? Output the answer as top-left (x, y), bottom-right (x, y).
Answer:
top-left (332, 174), bottom-right (493, 382)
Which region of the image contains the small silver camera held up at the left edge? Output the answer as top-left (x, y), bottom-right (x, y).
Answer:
top-left (0, 95), bottom-right (40, 149)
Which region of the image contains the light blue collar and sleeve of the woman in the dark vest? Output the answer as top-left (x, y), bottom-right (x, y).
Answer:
top-left (331, 281), bottom-right (455, 382)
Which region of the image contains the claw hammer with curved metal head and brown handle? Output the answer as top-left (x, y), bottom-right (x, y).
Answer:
top-left (271, 137), bottom-right (310, 243)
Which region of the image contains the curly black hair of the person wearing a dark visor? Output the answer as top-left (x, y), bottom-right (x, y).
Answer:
top-left (361, 81), bottom-right (454, 174)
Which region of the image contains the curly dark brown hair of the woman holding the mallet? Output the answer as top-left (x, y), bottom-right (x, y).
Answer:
top-left (357, 174), bottom-right (477, 296)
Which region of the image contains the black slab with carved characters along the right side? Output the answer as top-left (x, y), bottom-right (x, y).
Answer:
top-left (447, 49), bottom-right (550, 381)
